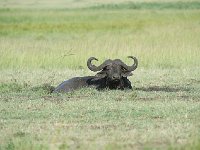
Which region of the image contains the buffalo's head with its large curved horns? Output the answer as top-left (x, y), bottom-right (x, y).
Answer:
top-left (87, 56), bottom-right (138, 86)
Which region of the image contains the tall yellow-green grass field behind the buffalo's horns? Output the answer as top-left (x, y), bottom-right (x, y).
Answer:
top-left (0, 3), bottom-right (200, 69)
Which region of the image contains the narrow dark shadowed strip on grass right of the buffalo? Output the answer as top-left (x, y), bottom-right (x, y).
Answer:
top-left (135, 86), bottom-right (190, 92)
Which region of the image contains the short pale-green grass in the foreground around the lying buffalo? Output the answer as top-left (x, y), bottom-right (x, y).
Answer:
top-left (0, 69), bottom-right (200, 149)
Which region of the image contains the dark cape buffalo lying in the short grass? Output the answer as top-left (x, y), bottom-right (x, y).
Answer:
top-left (53, 56), bottom-right (138, 93)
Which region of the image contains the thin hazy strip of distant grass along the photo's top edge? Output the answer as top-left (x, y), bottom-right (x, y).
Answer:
top-left (0, 0), bottom-right (199, 9)
